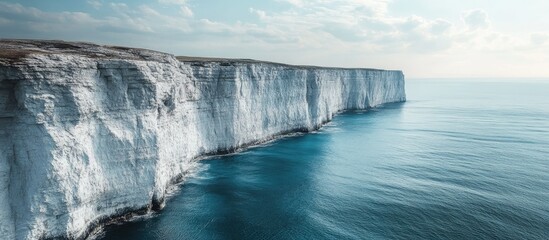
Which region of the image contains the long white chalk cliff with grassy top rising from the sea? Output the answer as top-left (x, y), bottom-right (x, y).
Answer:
top-left (0, 40), bottom-right (405, 239)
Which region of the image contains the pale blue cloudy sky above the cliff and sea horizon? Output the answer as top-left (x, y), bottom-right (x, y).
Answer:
top-left (0, 0), bottom-right (549, 78)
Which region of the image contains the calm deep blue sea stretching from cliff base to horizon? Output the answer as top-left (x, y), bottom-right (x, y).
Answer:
top-left (99, 80), bottom-right (549, 239)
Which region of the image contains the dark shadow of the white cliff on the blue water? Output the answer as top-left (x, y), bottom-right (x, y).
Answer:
top-left (100, 101), bottom-right (403, 240)
